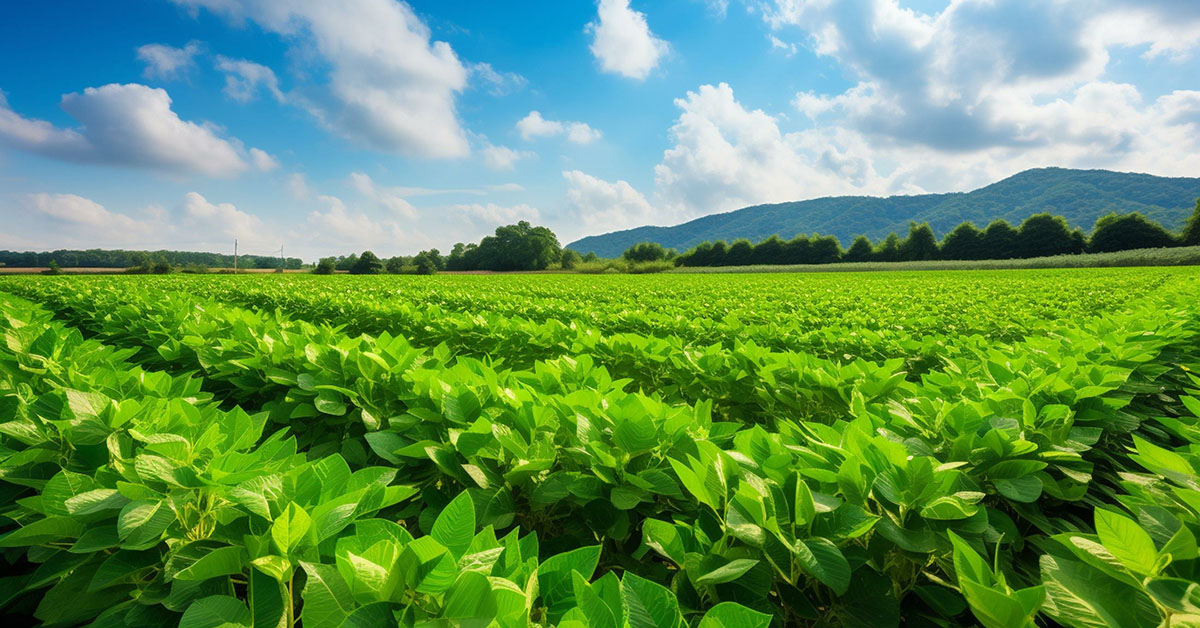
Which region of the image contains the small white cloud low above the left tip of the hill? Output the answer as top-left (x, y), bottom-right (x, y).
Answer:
top-left (563, 171), bottom-right (667, 241)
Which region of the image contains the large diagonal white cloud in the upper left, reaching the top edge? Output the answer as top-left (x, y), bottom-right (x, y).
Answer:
top-left (174, 0), bottom-right (469, 157)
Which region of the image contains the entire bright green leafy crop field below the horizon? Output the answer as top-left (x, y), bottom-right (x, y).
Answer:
top-left (0, 267), bottom-right (1200, 628)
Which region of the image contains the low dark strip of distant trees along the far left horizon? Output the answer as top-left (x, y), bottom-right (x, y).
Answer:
top-left (0, 249), bottom-right (302, 269)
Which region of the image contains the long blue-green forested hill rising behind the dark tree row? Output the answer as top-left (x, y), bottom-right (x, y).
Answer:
top-left (568, 168), bottom-right (1200, 257)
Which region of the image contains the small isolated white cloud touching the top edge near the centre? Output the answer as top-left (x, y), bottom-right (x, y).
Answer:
top-left (587, 0), bottom-right (670, 80)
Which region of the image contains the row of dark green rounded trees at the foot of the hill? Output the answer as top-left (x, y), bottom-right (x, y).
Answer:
top-left (667, 201), bottom-right (1200, 267)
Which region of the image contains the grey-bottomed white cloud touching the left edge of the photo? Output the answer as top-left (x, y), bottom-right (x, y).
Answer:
top-left (0, 83), bottom-right (264, 177)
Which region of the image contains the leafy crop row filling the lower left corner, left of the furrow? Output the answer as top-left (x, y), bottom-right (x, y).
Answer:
top-left (0, 298), bottom-right (770, 628)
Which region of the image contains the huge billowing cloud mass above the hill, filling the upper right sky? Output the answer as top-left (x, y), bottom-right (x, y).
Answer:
top-left (585, 0), bottom-right (1200, 223)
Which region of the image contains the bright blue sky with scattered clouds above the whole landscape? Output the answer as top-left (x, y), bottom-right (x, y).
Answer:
top-left (0, 0), bottom-right (1200, 261)
